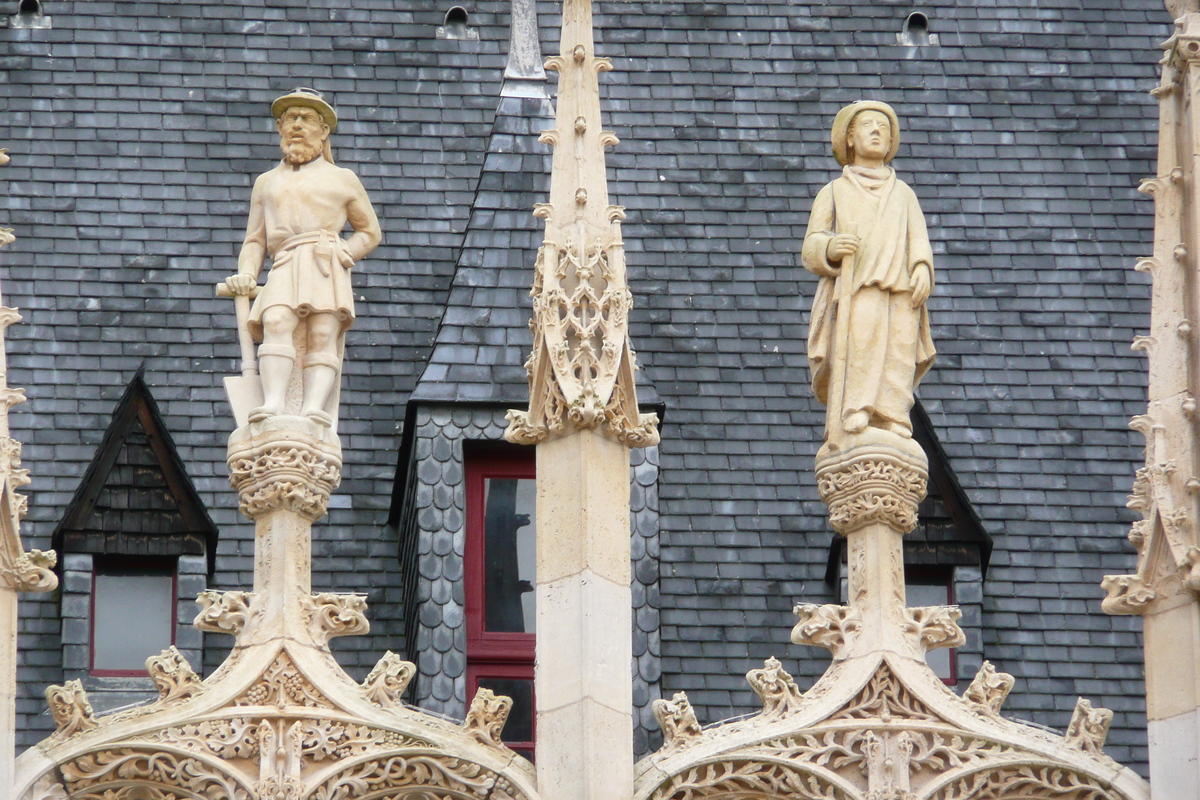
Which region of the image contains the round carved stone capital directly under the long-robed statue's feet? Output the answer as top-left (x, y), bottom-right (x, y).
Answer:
top-left (817, 448), bottom-right (929, 534)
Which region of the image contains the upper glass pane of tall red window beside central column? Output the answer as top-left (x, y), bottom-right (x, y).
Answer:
top-left (484, 477), bottom-right (536, 633)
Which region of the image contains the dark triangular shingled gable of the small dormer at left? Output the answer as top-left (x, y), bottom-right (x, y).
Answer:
top-left (54, 369), bottom-right (217, 570)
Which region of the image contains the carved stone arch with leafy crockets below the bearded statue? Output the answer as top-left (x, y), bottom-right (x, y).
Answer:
top-left (17, 593), bottom-right (536, 800)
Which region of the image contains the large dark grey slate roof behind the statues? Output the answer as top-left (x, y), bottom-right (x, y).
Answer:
top-left (0, 0), bottom-right (1170, 765)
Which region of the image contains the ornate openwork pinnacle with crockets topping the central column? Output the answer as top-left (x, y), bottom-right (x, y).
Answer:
top-left (504, 0), bottom-right (659, 447)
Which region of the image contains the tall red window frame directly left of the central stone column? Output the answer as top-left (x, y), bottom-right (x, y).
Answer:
top-left (463, 443), bottom-right (538, 759)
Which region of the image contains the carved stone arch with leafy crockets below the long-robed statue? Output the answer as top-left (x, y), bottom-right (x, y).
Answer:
top-left (634, 654), bottom-right (1148, 800)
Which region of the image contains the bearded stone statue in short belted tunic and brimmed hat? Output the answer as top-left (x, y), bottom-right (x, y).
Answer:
top-left (224, 89), bottom-right (382, 427)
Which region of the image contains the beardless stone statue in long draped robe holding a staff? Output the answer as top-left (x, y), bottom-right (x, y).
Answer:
top-left (802, 101), bottom-right (935, 446)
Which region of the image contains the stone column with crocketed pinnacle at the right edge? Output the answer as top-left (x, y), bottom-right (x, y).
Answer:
top-left (1103, 10), bottom-right (1200, 800)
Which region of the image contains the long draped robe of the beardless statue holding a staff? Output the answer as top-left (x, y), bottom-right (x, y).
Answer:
top-left (800, 167), bottom-right (935, 431)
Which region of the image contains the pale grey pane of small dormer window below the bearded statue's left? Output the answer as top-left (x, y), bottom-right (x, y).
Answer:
top-left (92, 570), bottom-right (174, 672)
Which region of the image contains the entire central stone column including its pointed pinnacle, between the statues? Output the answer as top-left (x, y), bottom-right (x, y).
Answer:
top-left (505, 0), bottom-right (659, 800)
